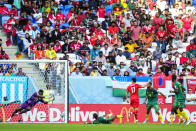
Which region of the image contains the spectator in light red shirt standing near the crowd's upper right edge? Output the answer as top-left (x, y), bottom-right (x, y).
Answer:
top-left (182, 15), bottom-right (193, 33)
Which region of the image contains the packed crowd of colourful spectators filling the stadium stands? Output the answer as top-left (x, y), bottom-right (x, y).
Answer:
top-left (0, 0), bottom-right (196, 77)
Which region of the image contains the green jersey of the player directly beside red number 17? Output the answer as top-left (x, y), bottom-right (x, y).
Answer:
top-left (146, 88), bottom-right (158, 104)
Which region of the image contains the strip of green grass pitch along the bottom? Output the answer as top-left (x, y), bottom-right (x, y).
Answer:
top-left (0, 123), bottom-right (196, 131)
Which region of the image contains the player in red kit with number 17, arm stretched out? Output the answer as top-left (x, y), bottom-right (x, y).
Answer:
top-left (126, 78), bottom-right (150, 122)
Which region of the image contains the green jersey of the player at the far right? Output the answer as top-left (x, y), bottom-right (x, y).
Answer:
top-left (173, 81), bottom-right (185, 101)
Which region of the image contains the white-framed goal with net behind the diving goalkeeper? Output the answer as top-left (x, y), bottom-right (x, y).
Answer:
top-left (0, 60), bottom-right (69, 123)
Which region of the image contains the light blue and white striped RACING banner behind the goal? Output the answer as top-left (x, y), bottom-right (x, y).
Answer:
top-left (0, 76), bottom-right (27, 103)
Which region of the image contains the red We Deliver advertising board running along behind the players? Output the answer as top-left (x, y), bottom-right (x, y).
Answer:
top-left (0, 104), bottom-right (196, 123)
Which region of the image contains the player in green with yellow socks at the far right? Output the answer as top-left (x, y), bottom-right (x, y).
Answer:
top-left (171, 75), bottom-right (191, 125)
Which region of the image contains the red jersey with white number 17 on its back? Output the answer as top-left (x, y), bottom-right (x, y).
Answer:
top-left (127, 83), bottom-right (142, 100)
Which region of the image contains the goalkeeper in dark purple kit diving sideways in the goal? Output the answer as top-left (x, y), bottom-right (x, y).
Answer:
top-left (7, 89), bottom-right (48, 122)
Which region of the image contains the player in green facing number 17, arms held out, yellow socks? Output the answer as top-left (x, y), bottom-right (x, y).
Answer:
top-left (143, 82), bottom-right (166, 124)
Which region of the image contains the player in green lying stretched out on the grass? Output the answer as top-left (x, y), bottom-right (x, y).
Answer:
top-left (86, 113), bottom-right (123, 124)
